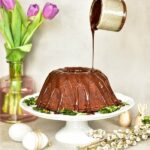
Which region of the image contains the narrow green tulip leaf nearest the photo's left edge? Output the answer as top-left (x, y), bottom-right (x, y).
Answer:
top-left (3, 9), bottom-right (14, 48)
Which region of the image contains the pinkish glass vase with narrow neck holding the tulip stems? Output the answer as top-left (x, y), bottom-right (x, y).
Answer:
top-left (0, 62), bottom-right (37, 123)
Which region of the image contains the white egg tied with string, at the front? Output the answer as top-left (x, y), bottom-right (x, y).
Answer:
top-left (22, 132), bottom-right (48, 150)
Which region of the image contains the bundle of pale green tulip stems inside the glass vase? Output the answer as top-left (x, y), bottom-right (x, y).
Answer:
top-left (2, 62), bottom-right (22, 115)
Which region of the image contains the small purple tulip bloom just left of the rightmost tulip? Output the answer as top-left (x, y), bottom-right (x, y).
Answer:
top-left (27, 4), bottom-right (40, 17)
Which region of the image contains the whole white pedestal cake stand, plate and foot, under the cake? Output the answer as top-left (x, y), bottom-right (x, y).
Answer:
top-left (20, 93), bottom-right (134, 145)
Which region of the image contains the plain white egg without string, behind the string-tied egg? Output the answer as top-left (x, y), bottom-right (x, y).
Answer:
top-left (8, 123), bottom-right (32, 142)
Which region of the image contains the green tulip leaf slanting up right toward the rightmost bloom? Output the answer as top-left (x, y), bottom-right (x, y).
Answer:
top-left (22, 12), bottom-right (43, 45)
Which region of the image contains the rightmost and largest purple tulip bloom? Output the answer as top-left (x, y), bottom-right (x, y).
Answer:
top-left (43, 3), bottom-right (59, 20)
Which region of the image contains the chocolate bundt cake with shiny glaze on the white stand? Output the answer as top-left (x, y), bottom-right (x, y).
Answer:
top-left (37, 67), bottom-right (121, 113)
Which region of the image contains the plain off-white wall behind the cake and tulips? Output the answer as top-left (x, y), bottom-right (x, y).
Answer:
top-left (0, 0), bottom-right (150, 113)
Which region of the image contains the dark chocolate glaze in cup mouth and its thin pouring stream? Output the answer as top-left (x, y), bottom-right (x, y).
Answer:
top-left (90, 0), bottom-right (101, 70)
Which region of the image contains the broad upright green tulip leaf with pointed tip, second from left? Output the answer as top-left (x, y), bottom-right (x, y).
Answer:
top-left (11, 7), bottom-right (21, 47)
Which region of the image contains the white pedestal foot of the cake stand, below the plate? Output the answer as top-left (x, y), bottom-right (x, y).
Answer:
top-left (55, 121), bottom-right (93, 145)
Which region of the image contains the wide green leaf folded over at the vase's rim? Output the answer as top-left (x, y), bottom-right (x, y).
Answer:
top-left (5, 44), bottom-right (32, 62)
